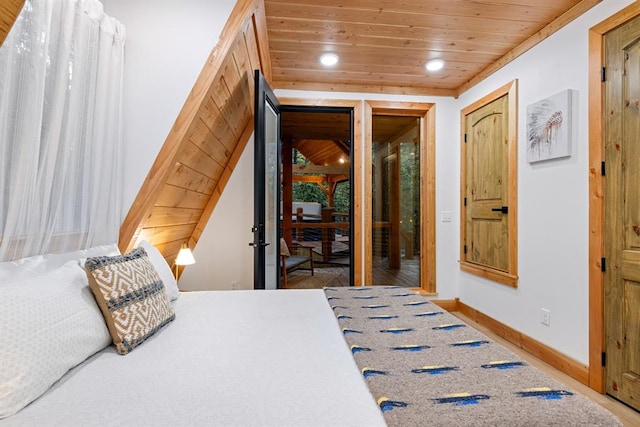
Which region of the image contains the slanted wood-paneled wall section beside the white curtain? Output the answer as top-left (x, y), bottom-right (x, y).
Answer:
top-left (119, 0), bottom-right (271, 265)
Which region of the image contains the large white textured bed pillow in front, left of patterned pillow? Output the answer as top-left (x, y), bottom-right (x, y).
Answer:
top-left (0, 260), bottom-right (111, 419)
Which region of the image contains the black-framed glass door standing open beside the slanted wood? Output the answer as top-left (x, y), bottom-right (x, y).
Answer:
top-left (249, 70), bottom-right (280, 289)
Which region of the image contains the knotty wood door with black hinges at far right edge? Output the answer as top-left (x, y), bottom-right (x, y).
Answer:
top-left (604, 18), bottom-right (640, 409)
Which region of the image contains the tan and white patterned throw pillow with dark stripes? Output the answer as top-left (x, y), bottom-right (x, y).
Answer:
top-left (85, 247), bottom-right (175, 355)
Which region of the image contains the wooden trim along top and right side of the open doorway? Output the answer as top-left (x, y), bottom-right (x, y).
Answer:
top-left (278, 97), bottom-right (364, 286)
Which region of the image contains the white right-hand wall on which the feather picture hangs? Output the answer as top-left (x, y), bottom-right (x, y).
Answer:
top-left (456, 0), bottom-right (632, 364)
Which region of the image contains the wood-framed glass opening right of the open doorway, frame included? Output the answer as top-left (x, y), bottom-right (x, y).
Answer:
top-left (363, 101), bottom-right (436, 295)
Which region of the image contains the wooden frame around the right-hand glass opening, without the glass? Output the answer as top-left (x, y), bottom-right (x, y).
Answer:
top-left (356, 101), bottom-right (436, 295)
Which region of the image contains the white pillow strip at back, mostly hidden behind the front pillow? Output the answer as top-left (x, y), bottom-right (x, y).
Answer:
top-left (0, 243), bottom-right (120, 285)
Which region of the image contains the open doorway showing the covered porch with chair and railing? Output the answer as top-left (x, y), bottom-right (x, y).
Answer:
top-left (280, 106), bottom-right (353, 288)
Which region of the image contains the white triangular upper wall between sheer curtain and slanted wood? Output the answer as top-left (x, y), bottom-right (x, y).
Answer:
top-left (103, 0), bottom-right (236, 218)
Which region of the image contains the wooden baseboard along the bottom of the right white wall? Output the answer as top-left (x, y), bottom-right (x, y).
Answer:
top-left (456, 300), bottom-right (589, 386)
